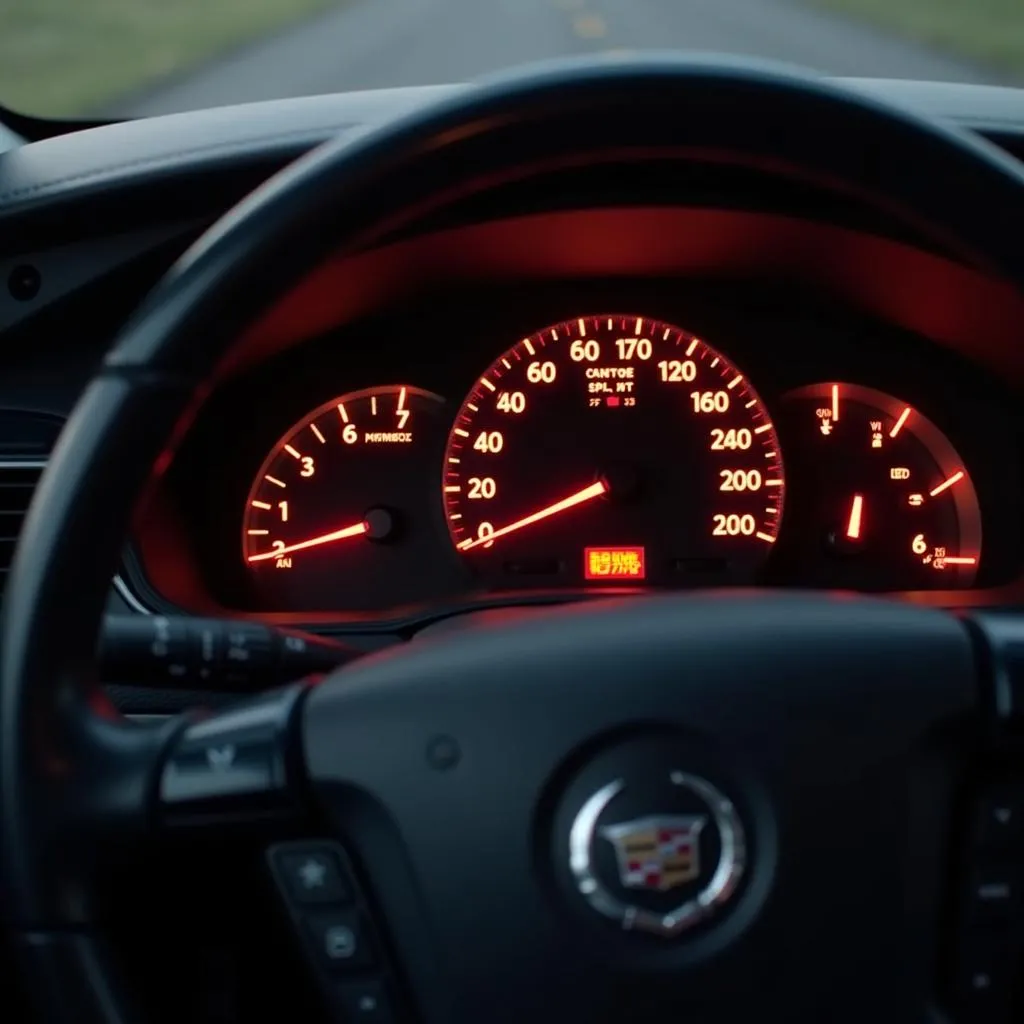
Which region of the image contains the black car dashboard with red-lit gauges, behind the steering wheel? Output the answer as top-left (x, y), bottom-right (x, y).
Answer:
top-left (0, 75), bottom-right (1024, 659)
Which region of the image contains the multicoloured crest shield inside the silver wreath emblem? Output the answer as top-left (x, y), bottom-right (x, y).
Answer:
top-left (601, 814), bottom-right (708, 892)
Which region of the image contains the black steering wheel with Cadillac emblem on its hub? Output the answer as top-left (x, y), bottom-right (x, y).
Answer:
top-left (0, 57), bottom-right (1024, 1024)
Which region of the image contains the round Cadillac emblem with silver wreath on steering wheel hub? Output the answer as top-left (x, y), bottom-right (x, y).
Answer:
top-left (567, 768), bottom-right (746, 939)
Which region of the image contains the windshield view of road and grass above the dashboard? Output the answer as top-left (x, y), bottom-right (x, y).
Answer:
top-left (0, 0), bottom-right (1024, 117)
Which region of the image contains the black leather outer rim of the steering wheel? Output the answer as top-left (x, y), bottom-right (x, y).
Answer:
top-left (0, 57), bottom-right (1024, 1021)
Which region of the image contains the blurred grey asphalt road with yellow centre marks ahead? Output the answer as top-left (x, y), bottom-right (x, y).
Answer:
top-left (119, 0), bottom-right (986, 115)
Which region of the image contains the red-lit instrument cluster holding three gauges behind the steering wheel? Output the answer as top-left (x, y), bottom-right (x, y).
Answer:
top-left (133, 284), bottom-right (1021, 620)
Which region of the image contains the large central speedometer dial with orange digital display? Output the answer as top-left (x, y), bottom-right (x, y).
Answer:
top-left (442, 314), bottom-right (785, 588)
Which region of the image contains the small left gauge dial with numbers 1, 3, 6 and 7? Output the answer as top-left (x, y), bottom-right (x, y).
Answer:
top-left (242, 385), bottom-right (443, 608)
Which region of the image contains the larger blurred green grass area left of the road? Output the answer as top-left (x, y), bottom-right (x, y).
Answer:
top-left (0, 0), bottom-right (338, 117)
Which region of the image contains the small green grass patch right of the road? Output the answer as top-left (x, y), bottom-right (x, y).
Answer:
top-left (804, 0), bottom-right (1024, 76)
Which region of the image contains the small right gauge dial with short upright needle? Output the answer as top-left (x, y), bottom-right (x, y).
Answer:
top-left (776, 383), bottom-right (981, 590)
